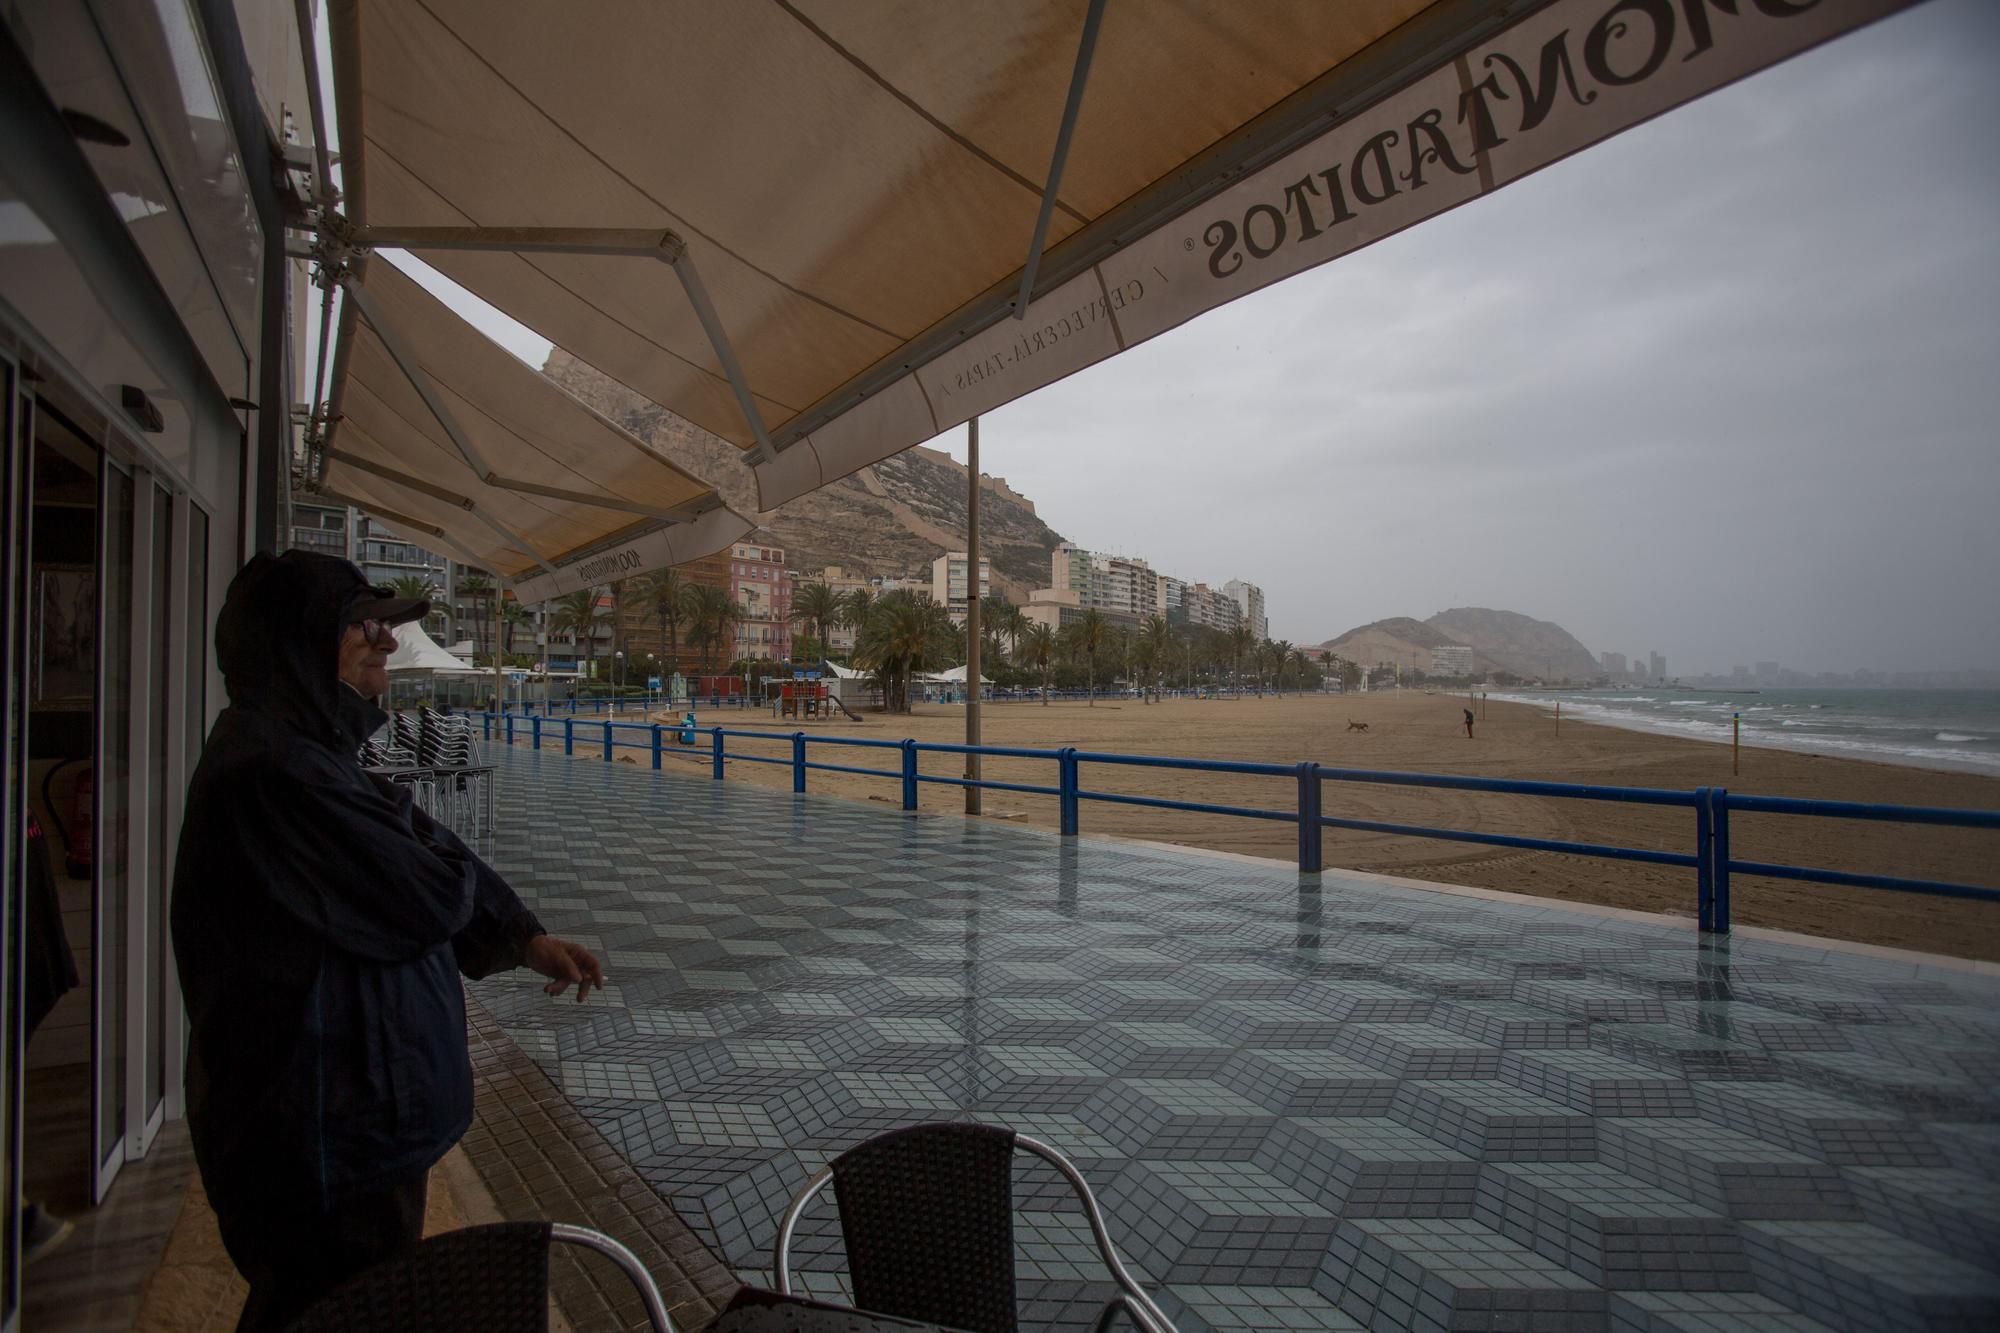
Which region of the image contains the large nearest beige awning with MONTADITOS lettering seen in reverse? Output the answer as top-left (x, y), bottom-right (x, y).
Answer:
top-left (332, 0), bottom-right (1910, 508)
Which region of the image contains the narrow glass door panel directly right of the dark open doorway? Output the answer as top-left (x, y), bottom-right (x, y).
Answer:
top-left (90, 454), bottom-right (138, 1201)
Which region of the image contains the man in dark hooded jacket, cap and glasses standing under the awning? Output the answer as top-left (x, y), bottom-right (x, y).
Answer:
top-left (172, 550), bottom-right (602, 1329)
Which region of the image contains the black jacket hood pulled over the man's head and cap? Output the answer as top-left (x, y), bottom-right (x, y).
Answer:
top-left (216, 550), bottom-right (386, 751)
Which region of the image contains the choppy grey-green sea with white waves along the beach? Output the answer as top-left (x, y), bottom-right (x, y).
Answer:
top-left (1490, 689), bottom-right (2000, 777)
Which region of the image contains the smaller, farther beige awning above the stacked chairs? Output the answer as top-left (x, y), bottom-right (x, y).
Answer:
top-left (316, 258), bottom-right (750, 600)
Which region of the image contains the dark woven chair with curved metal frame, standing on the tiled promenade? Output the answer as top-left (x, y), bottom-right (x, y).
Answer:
top-left (772, 1123), bottom-right (1174, 1333)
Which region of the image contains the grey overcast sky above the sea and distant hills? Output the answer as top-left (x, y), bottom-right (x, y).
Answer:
top-left (376, 0), bottom-right (2000, 675)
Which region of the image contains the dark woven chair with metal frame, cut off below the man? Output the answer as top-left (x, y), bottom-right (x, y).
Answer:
top-left (290, 1223), bottom-right (674, 1333)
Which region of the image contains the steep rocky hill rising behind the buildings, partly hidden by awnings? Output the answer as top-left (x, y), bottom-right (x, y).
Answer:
top-left (542, 350), bottom-right (1062, 602)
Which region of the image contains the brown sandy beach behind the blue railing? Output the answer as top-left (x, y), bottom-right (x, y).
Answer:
top-left (520, 693), bottom-right (2000, 959)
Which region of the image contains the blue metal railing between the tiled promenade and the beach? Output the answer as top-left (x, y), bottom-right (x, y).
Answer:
top-left (478, 713), bottom-right (2000, 933)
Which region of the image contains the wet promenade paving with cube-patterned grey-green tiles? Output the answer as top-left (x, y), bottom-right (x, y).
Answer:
top-left (472, 747), bottom-right (2000, 1333)
